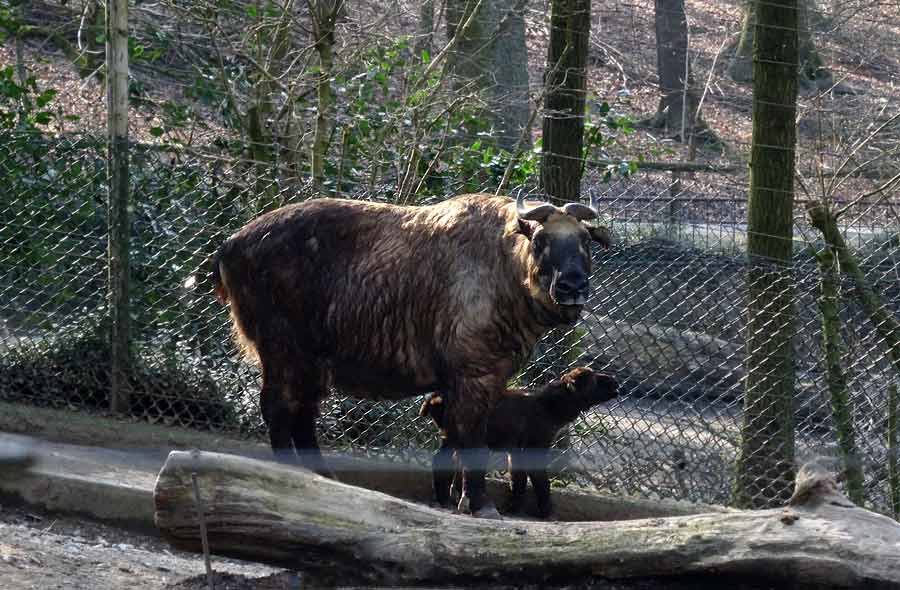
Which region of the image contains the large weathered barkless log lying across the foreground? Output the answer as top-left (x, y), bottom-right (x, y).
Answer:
top-left (154, 451), bottom-right (900, 588)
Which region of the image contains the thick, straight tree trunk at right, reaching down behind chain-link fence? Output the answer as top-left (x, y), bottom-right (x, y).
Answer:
top-left (735, 0), bottom-right (798, 507)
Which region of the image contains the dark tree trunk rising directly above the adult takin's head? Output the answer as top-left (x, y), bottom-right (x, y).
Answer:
top-left (541, 0), bottom-right (591, 202)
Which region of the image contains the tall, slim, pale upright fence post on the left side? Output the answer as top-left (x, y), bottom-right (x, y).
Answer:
top-left (106, 0), bottom-right (130, 412)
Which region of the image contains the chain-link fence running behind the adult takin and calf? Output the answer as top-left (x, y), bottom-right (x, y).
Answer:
top-left (0, 134), bottom-right (900, 512)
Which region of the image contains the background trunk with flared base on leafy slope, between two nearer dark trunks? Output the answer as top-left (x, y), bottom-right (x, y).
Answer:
top-left (651, 0), bottom-right (708, 143)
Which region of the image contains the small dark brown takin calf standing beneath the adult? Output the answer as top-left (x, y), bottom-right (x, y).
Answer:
top-left (419, 367), bottom-right (618, 518)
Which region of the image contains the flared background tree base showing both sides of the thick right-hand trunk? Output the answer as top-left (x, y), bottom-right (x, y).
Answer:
top-left (728, 0), bottom-right (834, 88)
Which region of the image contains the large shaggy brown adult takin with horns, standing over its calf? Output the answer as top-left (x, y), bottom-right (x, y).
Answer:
top-left (212, 193), bottom-right (609, 513)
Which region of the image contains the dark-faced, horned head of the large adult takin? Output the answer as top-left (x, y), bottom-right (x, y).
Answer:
top-left (516, 192), bottom-right (609, 323)
